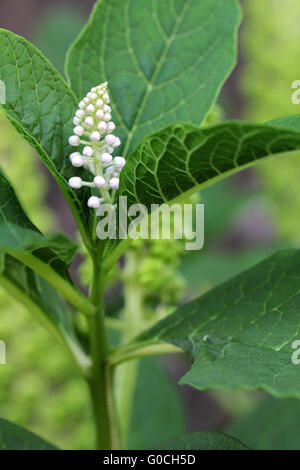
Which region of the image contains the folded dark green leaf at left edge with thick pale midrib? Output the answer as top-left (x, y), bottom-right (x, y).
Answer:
top-left (0, 172), bottom-right (93, 322)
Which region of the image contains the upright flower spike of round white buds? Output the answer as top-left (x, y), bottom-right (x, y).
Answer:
top-left (69, 82), bottom-right (126, 209)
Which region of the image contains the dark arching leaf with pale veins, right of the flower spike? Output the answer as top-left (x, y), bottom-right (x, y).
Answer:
top-left (119, 121), bottom-right (300, 209)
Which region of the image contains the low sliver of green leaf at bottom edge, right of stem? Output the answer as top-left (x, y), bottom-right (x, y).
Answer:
top-left (157, 431), bottom-right (250, 450)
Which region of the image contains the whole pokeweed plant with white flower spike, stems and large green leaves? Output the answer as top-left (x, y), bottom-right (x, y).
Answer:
top-left (0, 0), bottom-right (300, 449)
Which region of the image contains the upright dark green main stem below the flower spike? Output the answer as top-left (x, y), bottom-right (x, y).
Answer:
top-left (88, 256), bottom-right (119, 450)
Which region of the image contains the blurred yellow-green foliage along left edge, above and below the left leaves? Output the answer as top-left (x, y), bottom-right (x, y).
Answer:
top-left (0, 112), bottom-right (94, 448)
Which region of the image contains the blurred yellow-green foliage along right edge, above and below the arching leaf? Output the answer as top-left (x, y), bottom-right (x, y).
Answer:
top-left (241, 0), bottom-right (300, 244)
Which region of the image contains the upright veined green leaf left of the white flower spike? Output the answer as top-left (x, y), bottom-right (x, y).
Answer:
top-left (0, 29), bottom-right (89, 248)
